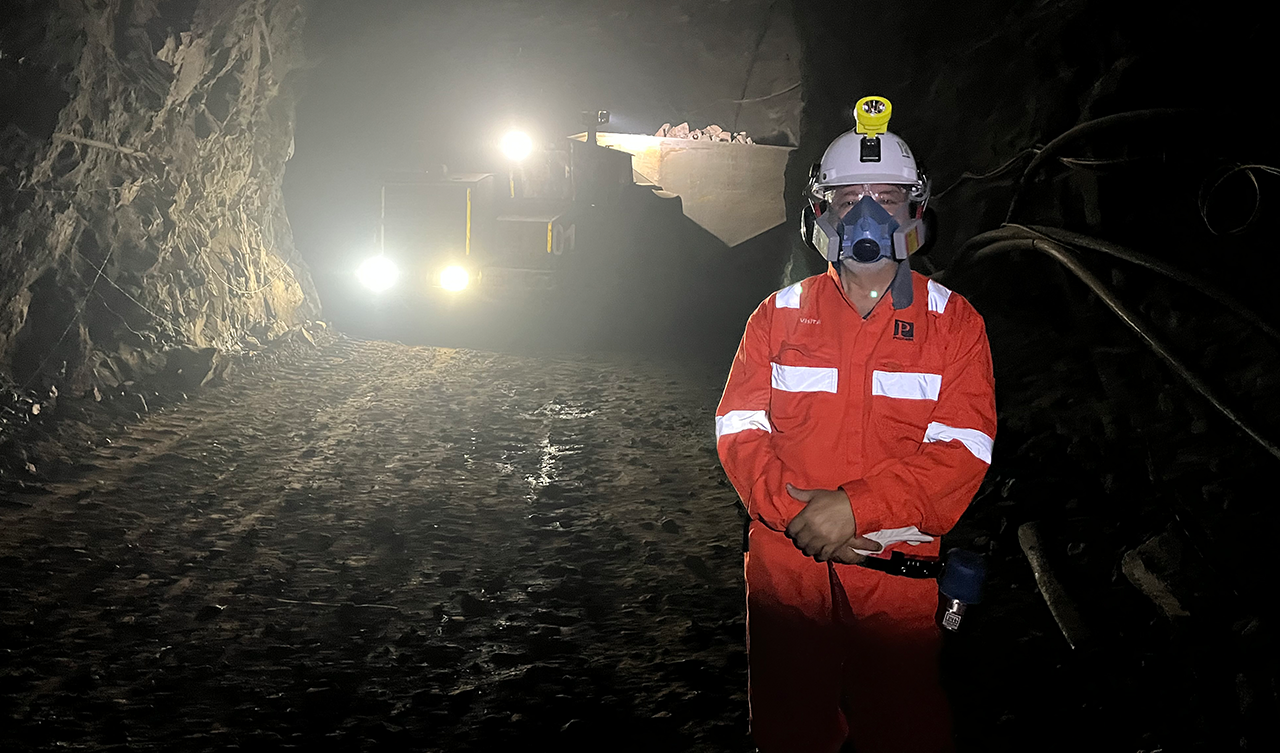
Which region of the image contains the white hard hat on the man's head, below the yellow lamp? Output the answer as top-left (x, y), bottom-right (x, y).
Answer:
top-left (809, 129), bottom-right (929, 207)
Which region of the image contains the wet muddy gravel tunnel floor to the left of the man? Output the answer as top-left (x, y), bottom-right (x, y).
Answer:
top-left (0, 339), bottom-right (746, 750)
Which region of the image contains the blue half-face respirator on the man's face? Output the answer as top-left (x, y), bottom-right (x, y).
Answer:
top-left (805, 195), bottom-right (924, 264)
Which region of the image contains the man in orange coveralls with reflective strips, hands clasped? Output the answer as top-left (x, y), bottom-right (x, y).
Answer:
top-left (716, 97), bottom-right (996, 753)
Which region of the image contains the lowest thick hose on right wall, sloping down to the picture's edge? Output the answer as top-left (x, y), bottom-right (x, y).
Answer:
top-left (965, 227), bottom-right (1280, 460)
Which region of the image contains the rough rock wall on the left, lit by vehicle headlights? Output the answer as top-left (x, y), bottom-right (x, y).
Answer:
top-left (0, 0), bottom-right (320, 391)
